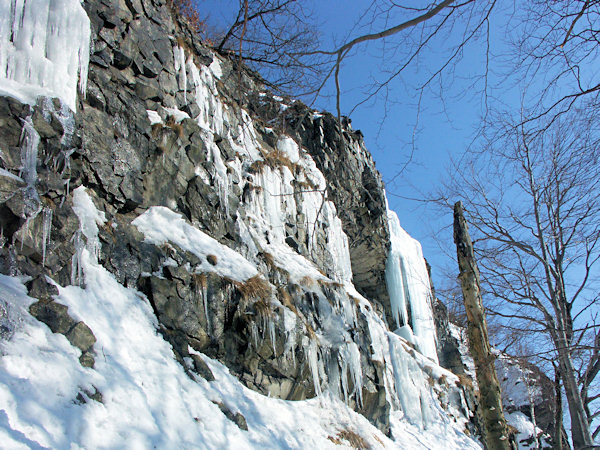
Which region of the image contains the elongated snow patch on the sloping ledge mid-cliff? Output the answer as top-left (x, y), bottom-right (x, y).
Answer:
top-left (132, 206), bottom-right (258, 281)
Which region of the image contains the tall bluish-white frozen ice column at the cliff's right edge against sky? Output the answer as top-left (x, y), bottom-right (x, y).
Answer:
top-left (386, 210), bottom-right (438, 362)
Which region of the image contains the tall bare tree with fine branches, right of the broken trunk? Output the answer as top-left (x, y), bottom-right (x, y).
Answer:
top-left (449, 111), bottom-right (600, 448)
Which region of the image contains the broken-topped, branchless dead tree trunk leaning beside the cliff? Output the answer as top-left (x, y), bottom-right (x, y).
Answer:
top-left (454, 202), bottom-right (513, 450)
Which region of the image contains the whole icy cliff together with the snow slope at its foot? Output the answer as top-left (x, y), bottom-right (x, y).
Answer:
top-left (0, 0), bottom-right (478, 448)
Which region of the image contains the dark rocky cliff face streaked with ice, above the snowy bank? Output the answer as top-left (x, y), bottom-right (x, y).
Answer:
top-left (0, 0), bottom-right (478, 444)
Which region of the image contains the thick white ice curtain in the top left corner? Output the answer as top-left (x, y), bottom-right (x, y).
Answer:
top-left (0, 0), bottom-right (90, 111)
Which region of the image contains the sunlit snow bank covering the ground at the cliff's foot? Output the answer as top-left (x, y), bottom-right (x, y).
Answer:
top-left (0, 249), bottom-right (479, 449)
